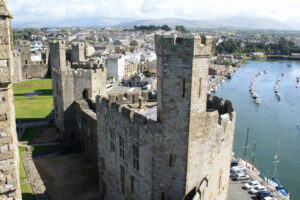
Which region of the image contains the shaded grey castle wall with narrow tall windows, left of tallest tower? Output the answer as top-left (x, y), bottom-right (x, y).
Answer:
top-left (96, 98), bottom-right (161, 200)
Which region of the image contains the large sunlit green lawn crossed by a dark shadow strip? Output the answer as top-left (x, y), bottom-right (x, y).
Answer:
top-left (13, 79), bottom-right (53, 119)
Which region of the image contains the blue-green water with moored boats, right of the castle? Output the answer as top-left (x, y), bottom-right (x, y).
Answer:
top-left (215, 60), bottom-right (300, 200)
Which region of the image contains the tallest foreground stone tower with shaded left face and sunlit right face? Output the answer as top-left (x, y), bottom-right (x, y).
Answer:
top-left (153, 35), bottom-right (235, 200)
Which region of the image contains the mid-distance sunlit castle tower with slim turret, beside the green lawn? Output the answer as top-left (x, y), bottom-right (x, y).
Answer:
top-left (50, 41), bottom-right (107, 140)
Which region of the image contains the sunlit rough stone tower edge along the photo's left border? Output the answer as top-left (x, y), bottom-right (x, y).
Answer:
top-left (0, 0), bottom-right (21, 200)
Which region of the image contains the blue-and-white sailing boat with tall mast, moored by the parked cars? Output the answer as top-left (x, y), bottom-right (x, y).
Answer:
top-left (265, 142), bottom-right (289, 197)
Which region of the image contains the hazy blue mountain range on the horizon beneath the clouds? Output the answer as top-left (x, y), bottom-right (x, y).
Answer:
top-left (13, 16), bottom-right (300, 30)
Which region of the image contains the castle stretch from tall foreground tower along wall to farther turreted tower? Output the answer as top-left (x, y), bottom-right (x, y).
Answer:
top-left (50, 35), bottom-right (236, 200)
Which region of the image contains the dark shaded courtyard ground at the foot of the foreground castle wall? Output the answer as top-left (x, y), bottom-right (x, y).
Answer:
top-left (33, 153), bottom-right (98, 200)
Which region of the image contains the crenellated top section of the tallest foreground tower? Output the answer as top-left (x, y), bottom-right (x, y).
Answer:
top-left (155, 34), bottom-right (212, 57)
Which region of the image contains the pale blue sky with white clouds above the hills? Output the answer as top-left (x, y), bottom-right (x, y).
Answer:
top-left (7, 0), bottom-right (300, 23)
